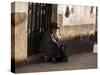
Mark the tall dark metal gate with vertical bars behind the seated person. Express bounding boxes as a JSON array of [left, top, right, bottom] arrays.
[[27, 3, 52, 56]]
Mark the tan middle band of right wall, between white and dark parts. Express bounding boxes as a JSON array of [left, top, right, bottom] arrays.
[[58, 24, 95, 39]]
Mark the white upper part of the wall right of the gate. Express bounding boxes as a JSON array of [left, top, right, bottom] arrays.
[[57, 4, 96, 25]]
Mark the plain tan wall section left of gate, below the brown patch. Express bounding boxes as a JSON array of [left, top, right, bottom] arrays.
[[15, 13, 27, 60]]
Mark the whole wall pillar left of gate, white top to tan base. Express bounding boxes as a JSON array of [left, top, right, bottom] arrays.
[[11, 2, 28, 61]]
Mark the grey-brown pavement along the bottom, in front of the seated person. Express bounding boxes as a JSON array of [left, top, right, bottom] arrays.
[[16, 52, 97, 73]]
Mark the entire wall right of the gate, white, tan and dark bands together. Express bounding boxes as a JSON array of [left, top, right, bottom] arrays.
[[57, 4, 97, 54]]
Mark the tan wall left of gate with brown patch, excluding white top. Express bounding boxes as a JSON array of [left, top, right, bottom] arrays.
[[12, 12, 27, 60]]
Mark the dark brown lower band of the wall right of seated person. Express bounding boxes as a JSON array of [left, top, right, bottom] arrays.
[[63, 34, 97, 55]]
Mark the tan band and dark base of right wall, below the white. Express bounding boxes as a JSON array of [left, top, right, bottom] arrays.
[[58, 24, 97, 55]]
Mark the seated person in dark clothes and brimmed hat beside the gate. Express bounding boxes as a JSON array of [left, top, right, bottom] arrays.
[[40, 23, 68, 63]]
